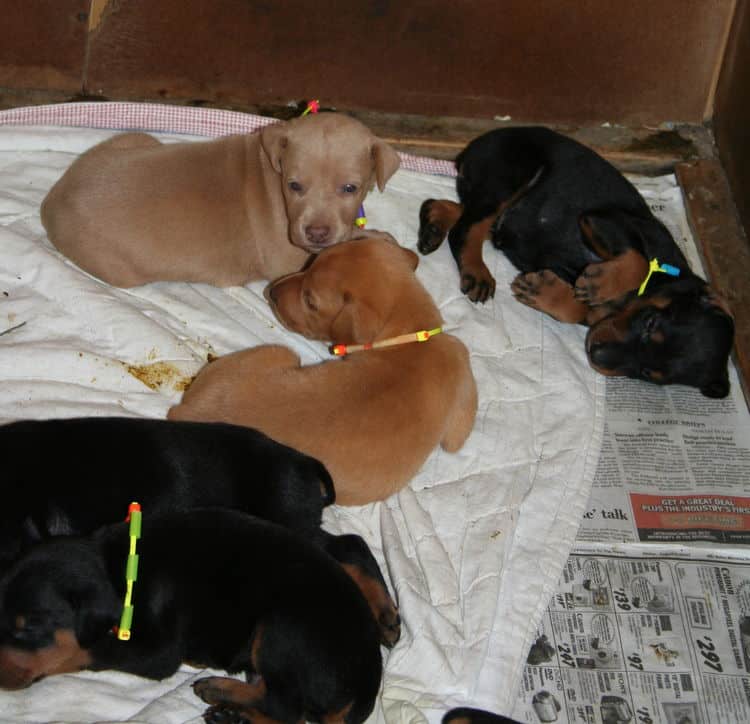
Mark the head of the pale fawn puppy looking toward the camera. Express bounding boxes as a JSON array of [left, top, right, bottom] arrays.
[[261, 113, 400, 254]]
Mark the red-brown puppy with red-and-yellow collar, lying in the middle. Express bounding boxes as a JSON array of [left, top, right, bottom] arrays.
[[169, 233, 477, 505]]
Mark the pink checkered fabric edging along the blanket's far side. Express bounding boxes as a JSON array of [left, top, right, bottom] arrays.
[[0, 102, 456, 176]]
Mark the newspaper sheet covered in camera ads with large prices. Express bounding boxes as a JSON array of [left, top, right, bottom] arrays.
[[514, 554, 750, 724]]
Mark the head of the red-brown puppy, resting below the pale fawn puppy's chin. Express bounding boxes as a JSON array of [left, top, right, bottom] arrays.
[[265, 232, 418, 344]]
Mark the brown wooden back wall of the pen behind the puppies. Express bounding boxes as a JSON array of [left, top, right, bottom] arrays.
[[0, 0, 735, 124]]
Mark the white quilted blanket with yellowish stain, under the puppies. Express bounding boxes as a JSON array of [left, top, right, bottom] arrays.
[[0, 121, 604, 724]]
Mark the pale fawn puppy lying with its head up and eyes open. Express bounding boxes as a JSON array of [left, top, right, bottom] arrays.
[[41, 113, 399, 287]]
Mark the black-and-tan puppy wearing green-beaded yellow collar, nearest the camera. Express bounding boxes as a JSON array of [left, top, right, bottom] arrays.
[[0, 508, 382, 724]]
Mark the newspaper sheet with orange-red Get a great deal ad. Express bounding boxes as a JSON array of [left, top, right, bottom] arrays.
[[578, 374, 750, 552]]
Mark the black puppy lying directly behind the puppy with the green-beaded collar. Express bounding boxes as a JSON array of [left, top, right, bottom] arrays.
[[0, 417, 400, 646]]
